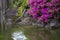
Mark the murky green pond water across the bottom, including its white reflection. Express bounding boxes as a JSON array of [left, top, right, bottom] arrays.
[[0, 25, 60, 40]]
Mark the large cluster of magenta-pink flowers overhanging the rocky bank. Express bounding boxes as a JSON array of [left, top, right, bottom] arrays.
[[27, 0, 60, 22]]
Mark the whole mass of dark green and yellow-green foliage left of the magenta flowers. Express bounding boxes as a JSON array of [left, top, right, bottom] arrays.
[[9, 0, 27, 17]]
